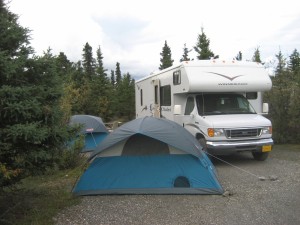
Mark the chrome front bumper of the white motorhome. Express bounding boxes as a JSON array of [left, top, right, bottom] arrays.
[[206, 138, 273, 155]]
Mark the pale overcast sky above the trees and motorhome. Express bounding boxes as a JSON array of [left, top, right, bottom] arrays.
[[8, 0, 300, 79]]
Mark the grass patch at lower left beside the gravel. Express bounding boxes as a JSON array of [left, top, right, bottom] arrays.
[[0, 163, 83, 225]]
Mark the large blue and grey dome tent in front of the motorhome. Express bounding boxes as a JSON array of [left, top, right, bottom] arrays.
[[73, 117, 223, 195]]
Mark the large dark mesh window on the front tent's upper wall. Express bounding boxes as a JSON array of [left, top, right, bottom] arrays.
[[122, 134, 170, 155]]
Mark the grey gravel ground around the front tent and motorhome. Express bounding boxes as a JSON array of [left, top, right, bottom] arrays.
[[54, 146, 300, 225]]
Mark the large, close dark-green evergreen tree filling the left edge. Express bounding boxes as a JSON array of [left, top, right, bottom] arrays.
[[0, 0, 67, 187]]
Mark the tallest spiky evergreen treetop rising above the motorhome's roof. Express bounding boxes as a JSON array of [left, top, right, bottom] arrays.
[[194, 27, 219, 60]]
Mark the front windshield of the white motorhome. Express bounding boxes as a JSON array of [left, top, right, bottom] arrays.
[[196, 93, 256, 116]]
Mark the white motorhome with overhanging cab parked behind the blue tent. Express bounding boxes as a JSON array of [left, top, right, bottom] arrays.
[[135, 60, 273, 160]]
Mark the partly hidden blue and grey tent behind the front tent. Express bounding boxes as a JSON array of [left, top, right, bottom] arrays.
[[70, 115, 108, 152]]
